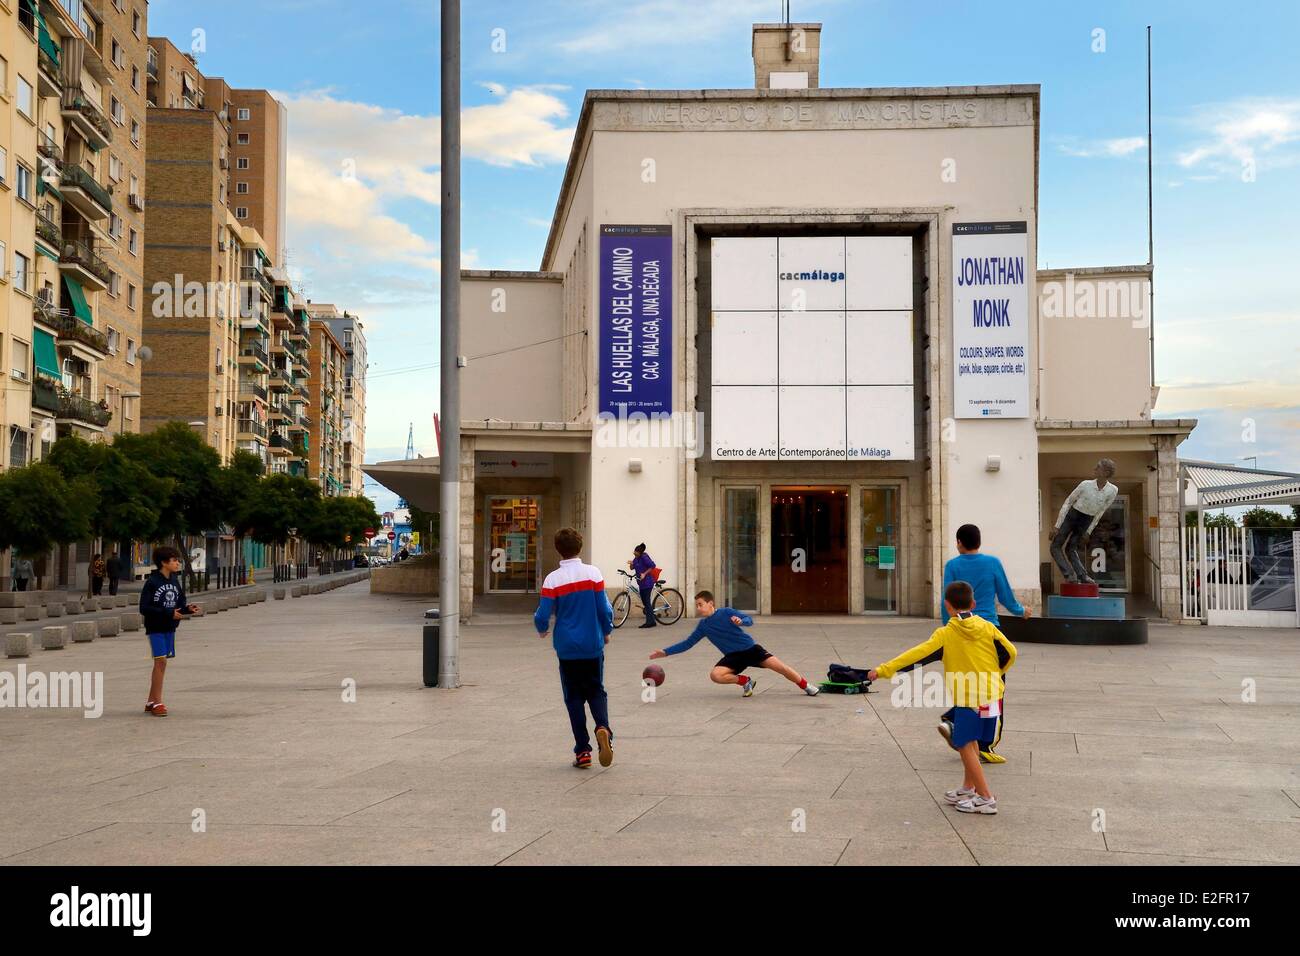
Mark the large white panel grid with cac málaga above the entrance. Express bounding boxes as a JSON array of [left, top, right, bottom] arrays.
[[711, 237, 915, 460]]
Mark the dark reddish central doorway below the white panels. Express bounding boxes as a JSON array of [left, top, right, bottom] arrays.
[[772, 485, 849, 614]]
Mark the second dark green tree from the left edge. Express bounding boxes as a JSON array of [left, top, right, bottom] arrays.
[[46, 436, 173, 541]]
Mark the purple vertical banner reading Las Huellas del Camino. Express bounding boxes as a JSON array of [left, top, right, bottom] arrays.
[[597, 226, 672, 415]]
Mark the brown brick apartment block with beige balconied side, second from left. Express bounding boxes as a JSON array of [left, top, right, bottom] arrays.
[[143, 36, 299, 472]]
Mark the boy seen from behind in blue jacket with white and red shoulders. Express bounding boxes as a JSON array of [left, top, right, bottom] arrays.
[[533, 528, 614, 770]]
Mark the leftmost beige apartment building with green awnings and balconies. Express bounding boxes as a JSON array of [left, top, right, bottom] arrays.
[[0, 0, 147, 464]]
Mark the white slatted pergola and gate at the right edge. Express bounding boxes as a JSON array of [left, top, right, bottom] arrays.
[[1178, 459, 1300, 627]]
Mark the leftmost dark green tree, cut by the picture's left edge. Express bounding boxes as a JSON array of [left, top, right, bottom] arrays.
[[0, 463, 96, 557]]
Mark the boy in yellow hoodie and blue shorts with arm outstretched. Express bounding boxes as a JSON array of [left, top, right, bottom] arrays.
[[867, 581, 1015, 813]]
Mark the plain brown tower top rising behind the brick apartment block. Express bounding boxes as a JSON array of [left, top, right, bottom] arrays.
[[230, 90, 289, 265]]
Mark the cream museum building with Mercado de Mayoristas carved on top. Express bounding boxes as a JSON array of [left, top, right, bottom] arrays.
[[371, 23, 1195, 619]]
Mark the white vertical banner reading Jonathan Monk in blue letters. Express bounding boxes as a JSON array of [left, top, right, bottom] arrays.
[[953, 222, 1032, 419]]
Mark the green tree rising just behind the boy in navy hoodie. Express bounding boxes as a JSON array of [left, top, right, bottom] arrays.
[[113, 421, 226, 568]]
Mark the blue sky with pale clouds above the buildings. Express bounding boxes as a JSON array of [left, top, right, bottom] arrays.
[[150, 0, 1300, 507]]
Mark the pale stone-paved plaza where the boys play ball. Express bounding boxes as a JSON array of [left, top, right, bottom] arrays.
[[0, 583, 1300, 865]]
